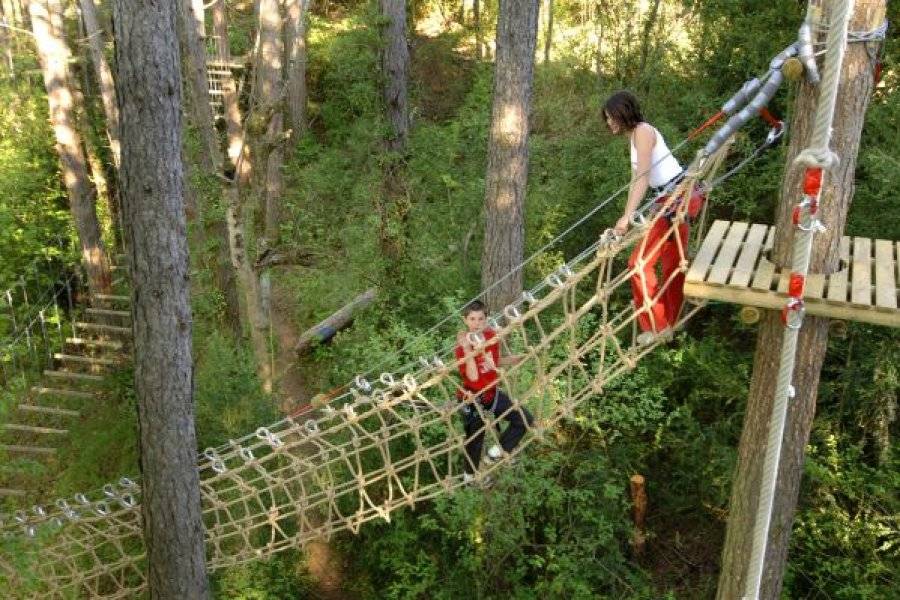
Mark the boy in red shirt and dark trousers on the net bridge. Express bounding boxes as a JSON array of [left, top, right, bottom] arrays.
[[455, 300, 532, 483]]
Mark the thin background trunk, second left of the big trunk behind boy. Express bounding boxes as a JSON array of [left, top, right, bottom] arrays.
[[284, 0, 312, 140]]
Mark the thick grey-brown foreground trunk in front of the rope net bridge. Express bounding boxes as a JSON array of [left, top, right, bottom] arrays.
[[115, 0, 209, 599]]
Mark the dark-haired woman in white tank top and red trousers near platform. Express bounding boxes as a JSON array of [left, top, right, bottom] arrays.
[[603, 91, 693, 345]]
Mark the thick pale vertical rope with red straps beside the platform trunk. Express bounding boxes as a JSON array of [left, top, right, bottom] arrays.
[[744, 0, 853, 600]]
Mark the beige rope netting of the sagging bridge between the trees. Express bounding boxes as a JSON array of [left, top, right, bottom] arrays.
[[0, 148, 725, 598]]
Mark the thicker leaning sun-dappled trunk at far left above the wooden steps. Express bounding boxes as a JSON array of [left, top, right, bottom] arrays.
[[28, 0, 110, 292]]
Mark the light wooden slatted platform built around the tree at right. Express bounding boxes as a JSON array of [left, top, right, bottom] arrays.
[[684, 221, 900, 327]]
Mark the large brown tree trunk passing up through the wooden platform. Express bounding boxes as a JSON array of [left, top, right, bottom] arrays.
[[717, 0, 885, 600]]
